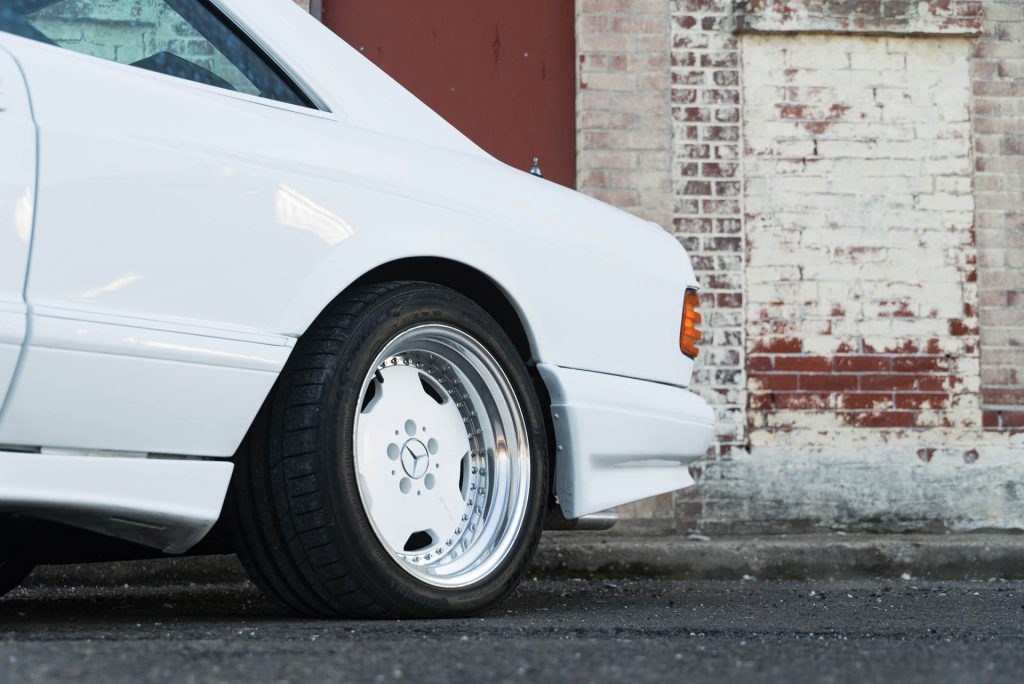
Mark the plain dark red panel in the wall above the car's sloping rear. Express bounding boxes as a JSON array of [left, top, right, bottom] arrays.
[[324, 0, 575, 187]]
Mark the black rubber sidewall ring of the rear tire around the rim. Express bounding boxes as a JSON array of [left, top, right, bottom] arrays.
[[301, 284, 548, 616]]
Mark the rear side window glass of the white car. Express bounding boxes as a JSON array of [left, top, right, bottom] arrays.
[[0, 0, 312, 106]]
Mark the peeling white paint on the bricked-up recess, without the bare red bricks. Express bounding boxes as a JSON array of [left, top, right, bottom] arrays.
[[743, 35, 979, 421]]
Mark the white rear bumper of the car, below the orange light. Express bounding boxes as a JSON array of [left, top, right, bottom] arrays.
[[538, 364, 715, 519]]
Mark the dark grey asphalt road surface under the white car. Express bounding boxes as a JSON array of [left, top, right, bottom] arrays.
[[0, 558, 1024, 684]]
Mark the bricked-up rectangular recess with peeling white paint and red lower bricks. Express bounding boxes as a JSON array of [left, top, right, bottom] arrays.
[[743, 35, 980, 432]]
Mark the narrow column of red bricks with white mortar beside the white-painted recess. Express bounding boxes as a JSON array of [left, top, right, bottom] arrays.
[[671, 0, 746, 528]]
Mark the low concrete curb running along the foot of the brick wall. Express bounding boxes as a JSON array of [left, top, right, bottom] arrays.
[[19, 532, 1024, 587]]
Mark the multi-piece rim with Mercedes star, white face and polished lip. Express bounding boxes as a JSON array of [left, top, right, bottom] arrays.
[[354, 325, 529, 588]]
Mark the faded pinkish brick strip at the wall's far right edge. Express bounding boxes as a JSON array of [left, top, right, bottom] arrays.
[[973, 0, 1024, 430]]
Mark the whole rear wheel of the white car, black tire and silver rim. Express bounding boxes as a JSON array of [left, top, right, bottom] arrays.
[[229, 283, 549, 617]]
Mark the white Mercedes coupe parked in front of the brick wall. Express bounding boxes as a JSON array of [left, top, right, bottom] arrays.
[[0, 0, 714, 616]]
